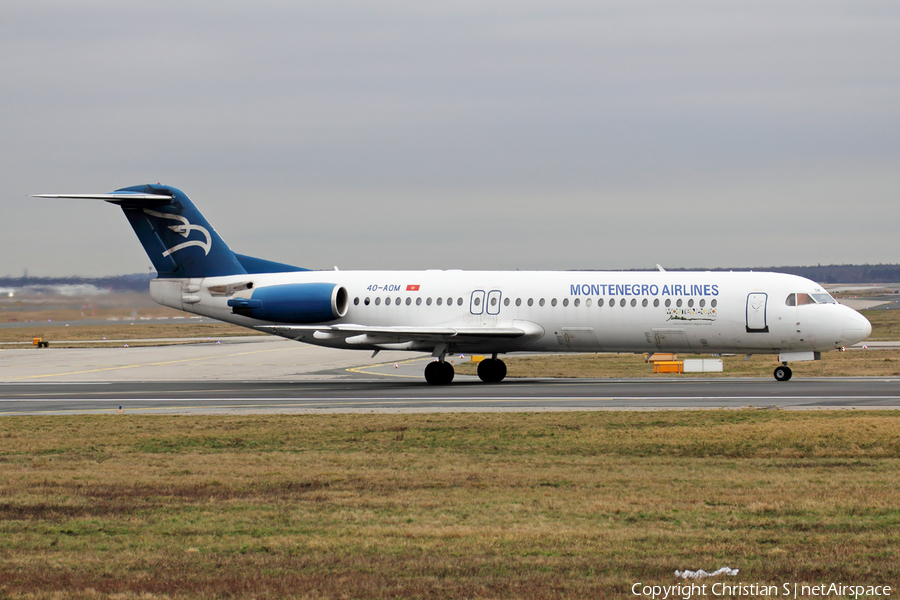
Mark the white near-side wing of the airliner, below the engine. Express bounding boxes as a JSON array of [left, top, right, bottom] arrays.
[[254, 321, 544, 345]]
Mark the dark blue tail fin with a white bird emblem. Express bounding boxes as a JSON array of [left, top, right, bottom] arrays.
[[108, 185, 247, 278]]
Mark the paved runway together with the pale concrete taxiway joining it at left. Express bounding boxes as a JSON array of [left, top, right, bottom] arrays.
[[0, 337, 900, 416]]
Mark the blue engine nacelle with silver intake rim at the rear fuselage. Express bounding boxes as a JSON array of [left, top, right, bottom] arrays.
[[228, 283, 350, 323]]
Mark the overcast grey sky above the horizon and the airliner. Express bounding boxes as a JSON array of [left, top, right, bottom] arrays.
[[0, 0, 900, 276]]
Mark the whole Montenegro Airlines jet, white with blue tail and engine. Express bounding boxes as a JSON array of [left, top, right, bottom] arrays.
[[39, 185, 872, 384]]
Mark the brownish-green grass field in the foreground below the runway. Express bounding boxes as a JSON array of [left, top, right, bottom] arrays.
[[0, 409, 900, 599]]
